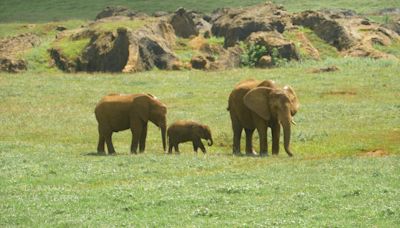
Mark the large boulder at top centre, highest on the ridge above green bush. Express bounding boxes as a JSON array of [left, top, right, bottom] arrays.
[[212, 2, 292, 47]]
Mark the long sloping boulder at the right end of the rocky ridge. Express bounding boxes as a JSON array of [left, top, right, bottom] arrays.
[[292, 10, 399, 58]]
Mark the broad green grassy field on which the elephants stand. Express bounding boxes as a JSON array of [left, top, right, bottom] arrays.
[[0, 58, 400, 227]]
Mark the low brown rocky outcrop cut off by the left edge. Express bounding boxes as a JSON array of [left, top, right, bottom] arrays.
[[0, 33, 40, 73]]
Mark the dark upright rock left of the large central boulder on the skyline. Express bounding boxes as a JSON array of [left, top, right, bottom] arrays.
[[169, 8, 199, 38]]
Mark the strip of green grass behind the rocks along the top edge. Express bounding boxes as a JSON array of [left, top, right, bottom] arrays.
[[0, 0, 399, 22]]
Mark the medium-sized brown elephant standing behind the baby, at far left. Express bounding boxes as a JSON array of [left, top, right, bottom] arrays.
[[94, 94, 167, 154]]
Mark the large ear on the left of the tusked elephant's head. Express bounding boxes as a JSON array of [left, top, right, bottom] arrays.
[[243, 87, 273, 120]]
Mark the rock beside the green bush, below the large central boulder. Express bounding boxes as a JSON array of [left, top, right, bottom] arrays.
[[246, 31, 300, 60]]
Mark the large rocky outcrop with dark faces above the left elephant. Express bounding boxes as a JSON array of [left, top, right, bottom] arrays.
[[49, 20, 177, 72]]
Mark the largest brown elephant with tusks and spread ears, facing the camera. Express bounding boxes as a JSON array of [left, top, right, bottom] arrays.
[[228, 79, 299, 156]]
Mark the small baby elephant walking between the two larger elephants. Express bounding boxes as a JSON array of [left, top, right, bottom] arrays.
[[167, 120, 213, 153]]
